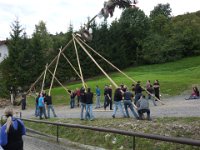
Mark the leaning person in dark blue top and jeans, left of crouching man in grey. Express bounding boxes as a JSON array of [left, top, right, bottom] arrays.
[[124, 89, 139, 119]]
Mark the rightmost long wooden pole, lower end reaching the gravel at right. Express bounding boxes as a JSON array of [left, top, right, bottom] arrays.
[[79, 38, 164, 105]]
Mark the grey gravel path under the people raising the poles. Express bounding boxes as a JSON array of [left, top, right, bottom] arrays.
[[0, 96, 200, 118]]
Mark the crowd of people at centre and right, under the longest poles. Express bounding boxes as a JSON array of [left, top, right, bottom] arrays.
[[64, 80, 160, 120]]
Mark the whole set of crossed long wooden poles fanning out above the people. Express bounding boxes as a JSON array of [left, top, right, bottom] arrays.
[[27, 34, 164, 107]]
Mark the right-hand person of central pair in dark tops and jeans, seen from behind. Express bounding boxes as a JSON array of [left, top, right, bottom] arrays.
[[85, 88, 94, 121]]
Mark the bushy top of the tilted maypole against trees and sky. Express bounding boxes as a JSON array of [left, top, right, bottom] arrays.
[[76, 0, 138, 42]]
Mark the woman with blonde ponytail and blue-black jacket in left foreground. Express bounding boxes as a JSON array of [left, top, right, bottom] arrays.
[[0, 107, 26, 150]]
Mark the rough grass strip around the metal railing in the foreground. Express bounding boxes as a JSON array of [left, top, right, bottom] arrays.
[[25, 117, 200, 150]]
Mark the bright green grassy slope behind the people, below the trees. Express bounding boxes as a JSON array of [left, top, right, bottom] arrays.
[[26, 56, 200, 105]]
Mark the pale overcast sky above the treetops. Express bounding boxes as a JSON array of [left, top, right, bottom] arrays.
[[0, 0, 200, 40]]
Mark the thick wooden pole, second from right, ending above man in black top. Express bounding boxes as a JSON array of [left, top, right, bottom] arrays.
[[73, 35, 118, 88]]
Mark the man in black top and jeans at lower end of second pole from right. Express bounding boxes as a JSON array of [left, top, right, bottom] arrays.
[[112, 87, 126, 118]]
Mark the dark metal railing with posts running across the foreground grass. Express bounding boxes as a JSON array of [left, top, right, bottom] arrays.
[[22, 119, 200, 150]]
